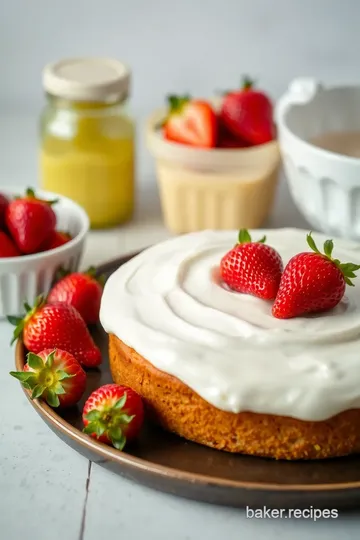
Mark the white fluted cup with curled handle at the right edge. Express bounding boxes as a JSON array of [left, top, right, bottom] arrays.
[[276, 78, 360, 241]]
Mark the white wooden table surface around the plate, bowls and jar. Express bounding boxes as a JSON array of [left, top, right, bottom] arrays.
[[0, 113, 360, 540]]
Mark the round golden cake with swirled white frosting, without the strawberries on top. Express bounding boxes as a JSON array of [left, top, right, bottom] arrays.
[[100, 229, 360, 459]]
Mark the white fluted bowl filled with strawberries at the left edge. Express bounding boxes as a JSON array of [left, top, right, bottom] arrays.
[[0, 189, 89, 317]]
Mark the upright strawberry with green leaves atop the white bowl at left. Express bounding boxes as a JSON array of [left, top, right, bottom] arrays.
[[5, 189, 56, 254]]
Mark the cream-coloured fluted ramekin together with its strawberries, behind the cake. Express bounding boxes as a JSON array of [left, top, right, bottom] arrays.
[[147, 80, 280, 234]]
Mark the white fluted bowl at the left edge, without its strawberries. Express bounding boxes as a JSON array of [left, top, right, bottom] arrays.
[[0, 189, 89, 317]]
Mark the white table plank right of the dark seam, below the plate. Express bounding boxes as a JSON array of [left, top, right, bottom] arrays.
[[84, 464, 360, 540]]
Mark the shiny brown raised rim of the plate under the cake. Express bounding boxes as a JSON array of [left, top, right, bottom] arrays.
[[15, 251, 360, 493]]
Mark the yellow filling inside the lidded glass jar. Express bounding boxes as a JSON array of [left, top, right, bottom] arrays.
[[40, 104, 135, 228]]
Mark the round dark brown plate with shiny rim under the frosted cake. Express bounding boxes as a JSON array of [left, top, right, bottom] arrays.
[[16, 257, 360, 509]]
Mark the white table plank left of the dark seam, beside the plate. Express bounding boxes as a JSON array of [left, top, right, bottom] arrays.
[[0, 322, 88, 540]]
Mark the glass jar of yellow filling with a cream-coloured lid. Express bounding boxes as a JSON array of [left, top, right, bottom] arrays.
[[40, 58, 135, 228]]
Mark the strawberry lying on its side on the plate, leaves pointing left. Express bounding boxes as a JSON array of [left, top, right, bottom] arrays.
[[8, 296, 101, 367]]
